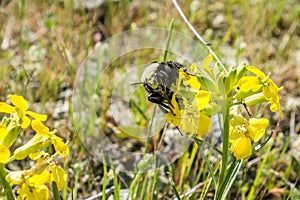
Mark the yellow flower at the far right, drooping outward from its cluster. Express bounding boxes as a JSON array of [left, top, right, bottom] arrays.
[[237, 66, 283, 117]]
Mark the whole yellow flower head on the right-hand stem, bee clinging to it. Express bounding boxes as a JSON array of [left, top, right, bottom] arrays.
[[165, 55, 283, 159]]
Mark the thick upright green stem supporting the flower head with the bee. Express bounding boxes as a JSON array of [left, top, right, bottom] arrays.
[[217, 97, 230, 197]]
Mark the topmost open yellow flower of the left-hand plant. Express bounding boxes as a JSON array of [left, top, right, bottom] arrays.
[[0, 95, 47, 128]]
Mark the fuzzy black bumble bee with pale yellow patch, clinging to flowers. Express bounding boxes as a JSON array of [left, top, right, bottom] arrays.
[[142, 61, 187, 114]]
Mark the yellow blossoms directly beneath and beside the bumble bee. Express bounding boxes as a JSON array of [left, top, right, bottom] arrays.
[[165, 66, 212, 137]]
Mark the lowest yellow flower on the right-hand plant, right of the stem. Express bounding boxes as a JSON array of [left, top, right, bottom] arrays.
[[229, 116, 269, 159]]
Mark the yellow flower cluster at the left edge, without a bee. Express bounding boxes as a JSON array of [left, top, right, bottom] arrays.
[[0, 95, 69, 199]]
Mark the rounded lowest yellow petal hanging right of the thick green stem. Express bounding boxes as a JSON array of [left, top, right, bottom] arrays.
[[229, 137, 252, 159]]
